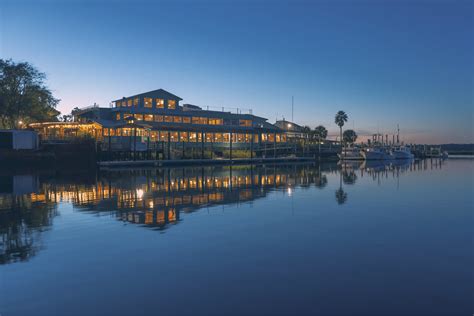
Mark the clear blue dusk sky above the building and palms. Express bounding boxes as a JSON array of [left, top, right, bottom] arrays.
[[0, 0, 474, 144]]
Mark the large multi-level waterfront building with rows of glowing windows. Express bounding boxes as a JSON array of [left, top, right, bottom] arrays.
[[30, 89, 287, 156]]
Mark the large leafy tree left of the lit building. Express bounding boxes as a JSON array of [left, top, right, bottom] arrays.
[[0, 59, 59, 128]]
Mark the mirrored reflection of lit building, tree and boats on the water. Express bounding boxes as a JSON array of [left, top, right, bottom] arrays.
[[0, 161, 442, 264]]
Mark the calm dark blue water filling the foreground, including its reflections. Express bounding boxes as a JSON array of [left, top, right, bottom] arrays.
[[0, 160, 474, 316]]
